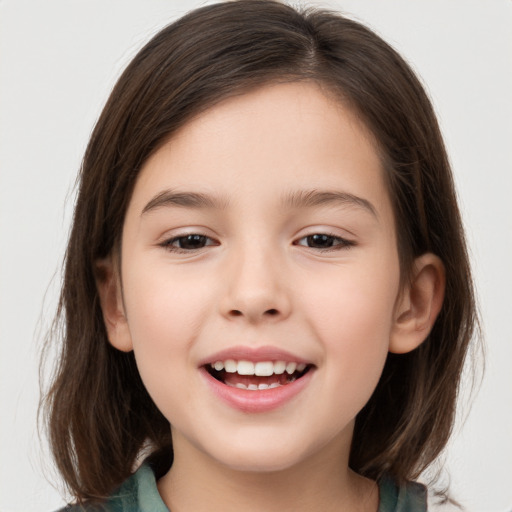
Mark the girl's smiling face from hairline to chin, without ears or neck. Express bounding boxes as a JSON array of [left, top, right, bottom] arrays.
[[112, 83, 399, 471]]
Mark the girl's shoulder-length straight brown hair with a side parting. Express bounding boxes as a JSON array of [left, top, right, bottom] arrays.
[[44, 0, 476, 501]]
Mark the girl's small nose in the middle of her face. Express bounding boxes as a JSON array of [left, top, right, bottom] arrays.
[[220, 246, 291, 324]]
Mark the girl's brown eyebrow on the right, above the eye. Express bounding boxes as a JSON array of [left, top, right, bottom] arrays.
[[283, 190, 378, 218]]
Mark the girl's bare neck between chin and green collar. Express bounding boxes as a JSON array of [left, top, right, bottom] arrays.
[[158, 428, 378, 512]]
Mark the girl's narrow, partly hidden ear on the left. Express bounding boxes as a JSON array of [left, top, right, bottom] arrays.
[[95, 257, 133, 352]]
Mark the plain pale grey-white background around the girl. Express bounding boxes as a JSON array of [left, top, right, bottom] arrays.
[[0, 0, 512, 512]]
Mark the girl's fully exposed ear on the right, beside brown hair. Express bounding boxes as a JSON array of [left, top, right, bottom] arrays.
[[389, 253, 445, 354]]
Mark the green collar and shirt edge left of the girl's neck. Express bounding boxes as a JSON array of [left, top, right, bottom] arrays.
[[57, 464, 169, 512]]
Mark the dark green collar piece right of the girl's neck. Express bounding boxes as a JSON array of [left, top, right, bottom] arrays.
[[378, 475, 427, 512]]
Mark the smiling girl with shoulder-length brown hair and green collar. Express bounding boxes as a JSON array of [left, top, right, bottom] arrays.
[[42, 0, 475, 512]]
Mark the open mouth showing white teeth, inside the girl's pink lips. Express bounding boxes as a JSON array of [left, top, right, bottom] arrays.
[[205, 359, 313, 391]]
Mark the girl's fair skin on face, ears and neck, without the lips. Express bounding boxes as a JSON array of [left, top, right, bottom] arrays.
[[98, 82, 444, 512]]
